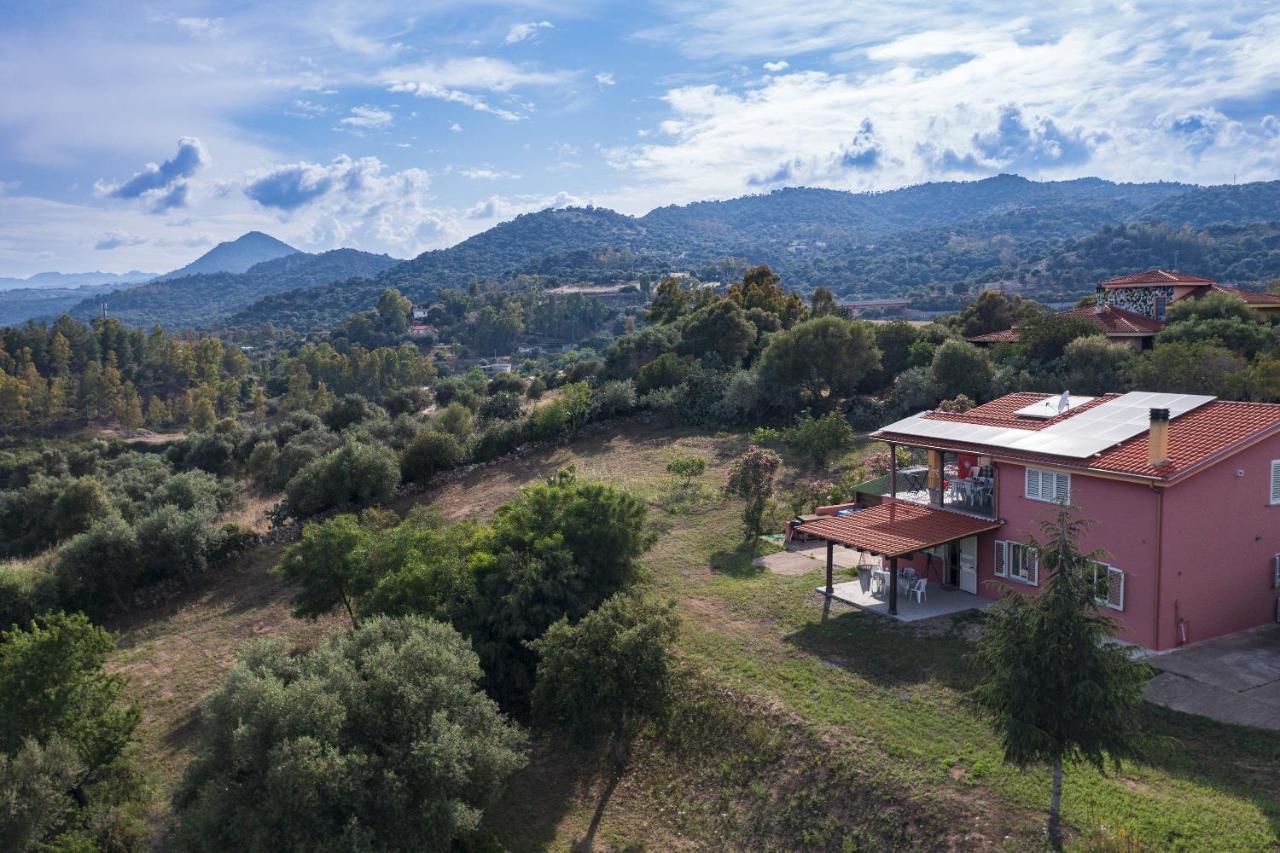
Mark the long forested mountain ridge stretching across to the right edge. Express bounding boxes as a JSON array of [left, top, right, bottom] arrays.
[[230, 175, 1280, 328]]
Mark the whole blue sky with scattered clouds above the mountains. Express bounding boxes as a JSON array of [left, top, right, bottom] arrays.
[[0, 0, 1280, 275]]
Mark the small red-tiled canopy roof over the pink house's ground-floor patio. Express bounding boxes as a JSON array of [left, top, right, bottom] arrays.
[[796, 501, 1001, 557]]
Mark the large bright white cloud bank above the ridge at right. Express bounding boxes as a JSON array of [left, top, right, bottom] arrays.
[[607, 9, 1280, 204]]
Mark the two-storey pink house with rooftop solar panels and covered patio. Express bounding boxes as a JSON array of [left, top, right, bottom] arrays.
[[792, 392, 1280, 649]]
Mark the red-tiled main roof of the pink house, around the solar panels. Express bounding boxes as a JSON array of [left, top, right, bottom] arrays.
[[876, 392, 1280, 480]]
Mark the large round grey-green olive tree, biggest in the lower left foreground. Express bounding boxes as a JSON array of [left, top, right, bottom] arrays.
[[177, 616, 526, 853]]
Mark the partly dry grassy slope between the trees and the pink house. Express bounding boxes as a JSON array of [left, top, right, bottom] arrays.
[[107, 424, 1280, 850]]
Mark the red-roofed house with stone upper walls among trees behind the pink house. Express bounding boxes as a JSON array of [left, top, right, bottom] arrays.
[[966, 269, 1280, 350]]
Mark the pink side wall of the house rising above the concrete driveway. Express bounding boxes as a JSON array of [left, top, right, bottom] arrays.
[[1160, 437, 1280, 648]]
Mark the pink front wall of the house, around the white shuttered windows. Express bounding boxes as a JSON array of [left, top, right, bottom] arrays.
[[978, 461, 1157, 646]]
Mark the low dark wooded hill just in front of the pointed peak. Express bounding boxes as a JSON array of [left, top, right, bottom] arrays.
[[68, 248, 399, 329]]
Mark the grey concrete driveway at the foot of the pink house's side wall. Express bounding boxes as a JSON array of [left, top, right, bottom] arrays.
[[1147, 625, 1280, 731]]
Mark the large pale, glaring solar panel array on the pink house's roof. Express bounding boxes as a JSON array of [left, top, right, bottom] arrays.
[[884, 391, 1215, 459]]
